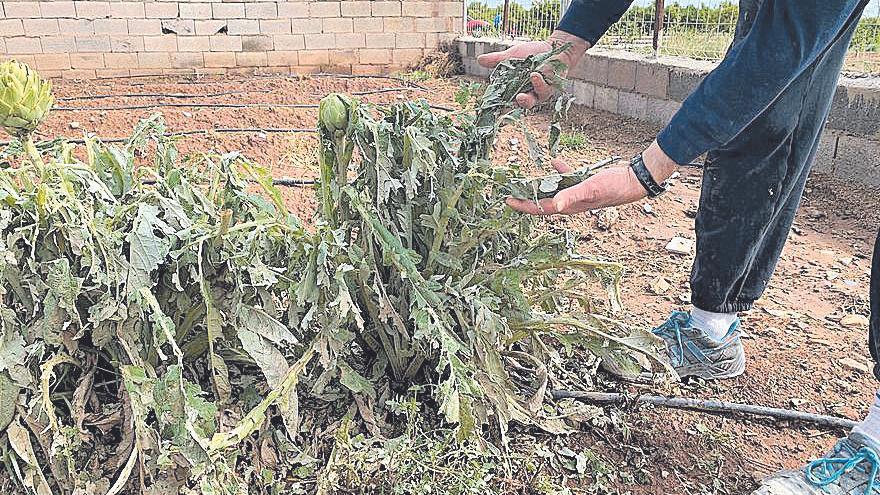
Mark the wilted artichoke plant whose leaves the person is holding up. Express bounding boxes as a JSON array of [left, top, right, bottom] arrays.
[[301, 45, 660, 439]]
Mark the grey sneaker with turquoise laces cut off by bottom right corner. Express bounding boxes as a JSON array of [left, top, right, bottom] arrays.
[[752, 433, 880, 495]]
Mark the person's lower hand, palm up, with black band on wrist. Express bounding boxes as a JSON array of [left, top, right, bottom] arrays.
[[507, 141, 677, 215]]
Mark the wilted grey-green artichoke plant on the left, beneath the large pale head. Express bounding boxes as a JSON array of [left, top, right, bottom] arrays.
[[0, 116, 308, 493]]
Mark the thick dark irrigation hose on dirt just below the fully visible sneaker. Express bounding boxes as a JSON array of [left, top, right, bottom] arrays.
[[551, 390, 857, 429]]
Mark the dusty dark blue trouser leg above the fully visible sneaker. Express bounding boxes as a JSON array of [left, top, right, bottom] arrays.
[[691, 0, 861, 313]]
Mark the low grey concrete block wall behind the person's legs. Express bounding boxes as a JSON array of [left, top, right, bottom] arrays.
[[458, 37, 880, 186]]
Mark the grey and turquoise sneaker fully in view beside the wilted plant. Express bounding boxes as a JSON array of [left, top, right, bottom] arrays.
[[653, 311, 746, 380]]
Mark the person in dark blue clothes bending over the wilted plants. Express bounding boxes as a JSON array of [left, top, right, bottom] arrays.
[[478, 0, 880, 495]]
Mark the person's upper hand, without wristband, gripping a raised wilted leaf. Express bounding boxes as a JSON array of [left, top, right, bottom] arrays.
[[477, 31, 590, 109]]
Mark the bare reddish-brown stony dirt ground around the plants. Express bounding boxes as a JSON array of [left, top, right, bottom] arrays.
[[34, 71, 880, 494]]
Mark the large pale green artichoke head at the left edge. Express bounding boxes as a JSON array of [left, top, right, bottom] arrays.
[[0, 60, 54, 138]]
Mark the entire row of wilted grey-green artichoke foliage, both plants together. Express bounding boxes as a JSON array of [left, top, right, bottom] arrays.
[[0, 47, 662, 495]]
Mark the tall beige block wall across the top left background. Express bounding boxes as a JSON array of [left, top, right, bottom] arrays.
[[0, 0, 463, 78]]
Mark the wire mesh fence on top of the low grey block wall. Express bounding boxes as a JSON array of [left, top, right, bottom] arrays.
[[465, 0, 880, 74]]
